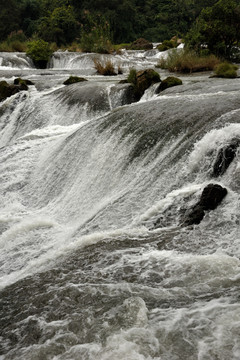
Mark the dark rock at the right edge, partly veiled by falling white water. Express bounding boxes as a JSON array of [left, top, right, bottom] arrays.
[[212, 139, 240, 177]]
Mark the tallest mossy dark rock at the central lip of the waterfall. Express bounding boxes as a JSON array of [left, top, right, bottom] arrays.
[[127, 69, 161, 101]]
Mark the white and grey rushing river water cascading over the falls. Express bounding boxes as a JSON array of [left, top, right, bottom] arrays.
[[0, 51, 240, 360]]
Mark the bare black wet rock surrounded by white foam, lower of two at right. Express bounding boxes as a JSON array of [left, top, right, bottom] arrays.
[[182, 184, 227, 226]]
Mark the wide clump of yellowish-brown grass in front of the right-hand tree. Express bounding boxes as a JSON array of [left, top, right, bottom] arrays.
[[157, 50, 219, 73]]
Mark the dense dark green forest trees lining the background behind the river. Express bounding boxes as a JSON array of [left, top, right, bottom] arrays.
[[0, 0, 240, 57]]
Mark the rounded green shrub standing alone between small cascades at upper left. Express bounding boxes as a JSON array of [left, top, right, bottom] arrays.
[[27, 39, 53, 69]]
